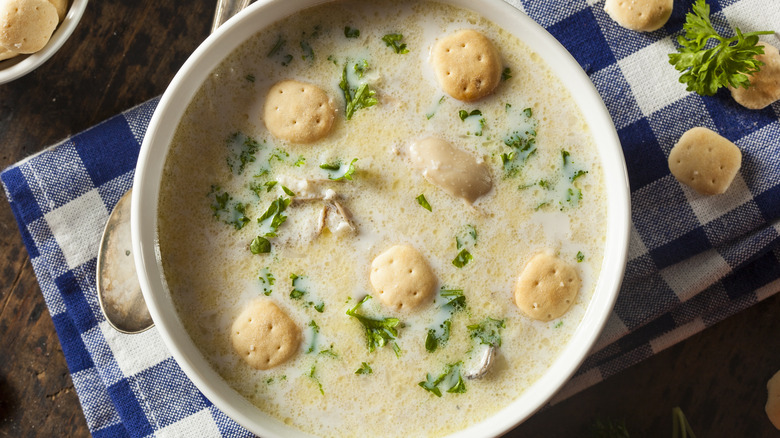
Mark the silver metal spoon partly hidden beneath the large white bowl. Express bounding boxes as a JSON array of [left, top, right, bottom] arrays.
[[96, 0, 251, 334]]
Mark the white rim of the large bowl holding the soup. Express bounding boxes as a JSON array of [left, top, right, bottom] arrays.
[[131, 0, 630, 438]]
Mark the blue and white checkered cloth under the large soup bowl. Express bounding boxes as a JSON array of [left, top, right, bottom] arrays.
[[1, 0, 780, 437]]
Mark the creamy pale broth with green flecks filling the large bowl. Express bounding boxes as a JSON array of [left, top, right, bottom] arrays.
[[158, 1, 606, 436]]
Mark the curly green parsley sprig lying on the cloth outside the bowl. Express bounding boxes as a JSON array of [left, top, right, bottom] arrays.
[[669, 0, 774, 96]]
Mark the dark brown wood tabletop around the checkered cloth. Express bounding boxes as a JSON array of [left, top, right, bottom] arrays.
[[0, 0, 780, 438]]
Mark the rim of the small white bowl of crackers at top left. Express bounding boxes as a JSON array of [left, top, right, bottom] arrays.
[[0, 0, 87, 84]]
